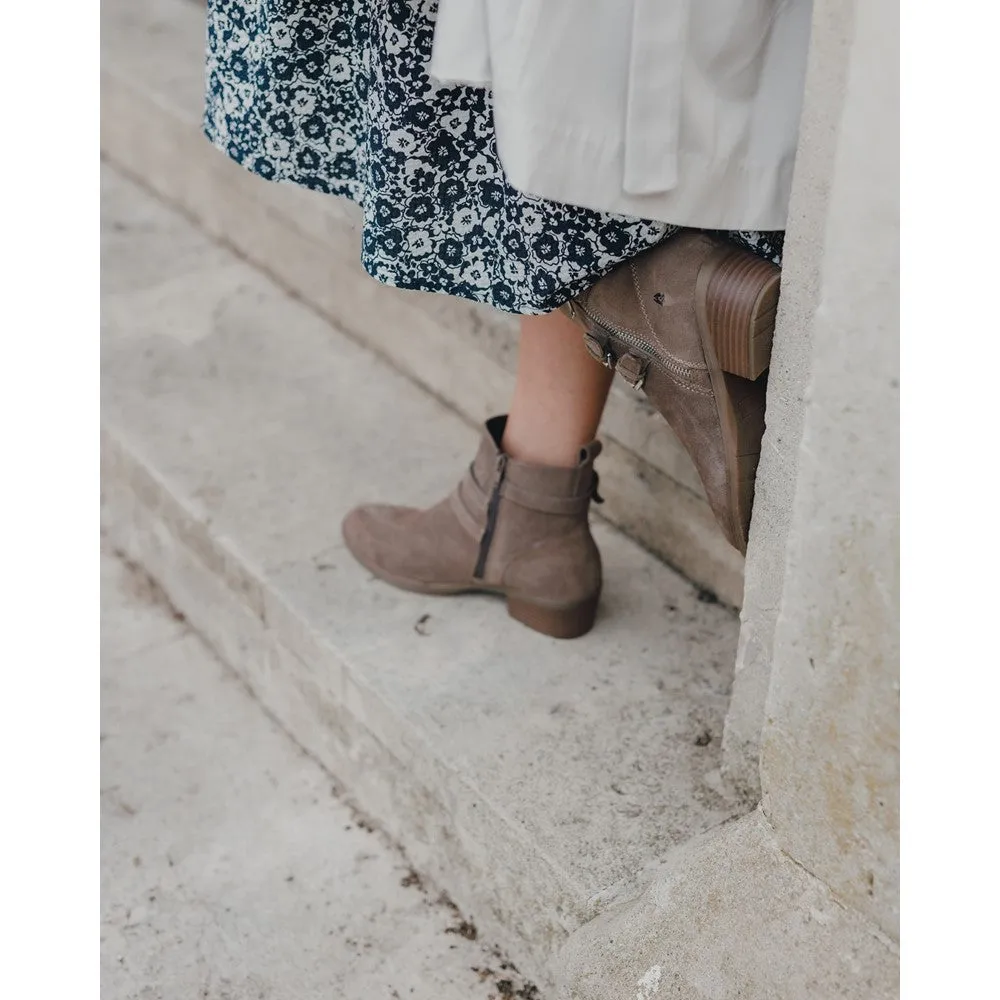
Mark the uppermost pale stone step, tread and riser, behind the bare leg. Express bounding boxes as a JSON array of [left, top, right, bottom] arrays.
[[101, 0, 743, 606]]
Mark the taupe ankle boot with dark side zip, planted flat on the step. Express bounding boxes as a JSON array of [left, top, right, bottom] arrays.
[[343, 416, 601, 639]]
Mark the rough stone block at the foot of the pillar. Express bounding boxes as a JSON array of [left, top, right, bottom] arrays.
[[558, 812, 899, 1000]]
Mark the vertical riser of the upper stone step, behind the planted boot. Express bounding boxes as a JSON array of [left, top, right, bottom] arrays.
[[101, 67, 743, 607]]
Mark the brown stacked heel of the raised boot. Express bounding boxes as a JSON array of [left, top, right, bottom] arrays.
[[696, 248, 781, 381]]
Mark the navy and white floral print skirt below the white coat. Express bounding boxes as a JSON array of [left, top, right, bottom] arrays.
[[204, 0, 783, 313]]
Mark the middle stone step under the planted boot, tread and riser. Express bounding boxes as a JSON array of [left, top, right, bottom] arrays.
[[102, 165, 740, 985]]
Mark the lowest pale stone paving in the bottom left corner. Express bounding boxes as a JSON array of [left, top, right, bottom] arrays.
[[101, 552, 542, 1000]]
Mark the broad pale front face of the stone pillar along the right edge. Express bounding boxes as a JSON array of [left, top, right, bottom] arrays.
[[761, 2, 899, 937]]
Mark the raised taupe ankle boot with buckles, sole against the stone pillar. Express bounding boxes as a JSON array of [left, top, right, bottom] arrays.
[[563, 231, 781, 552]]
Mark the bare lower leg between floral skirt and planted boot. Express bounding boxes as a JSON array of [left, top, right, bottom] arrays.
[[503, 311, 614, 467]]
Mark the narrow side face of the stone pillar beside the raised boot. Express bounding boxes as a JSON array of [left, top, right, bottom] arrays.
[[723, 0, 868, 802]]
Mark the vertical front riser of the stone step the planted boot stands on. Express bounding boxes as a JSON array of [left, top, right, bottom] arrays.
[[101, 424, 616, 987]]
